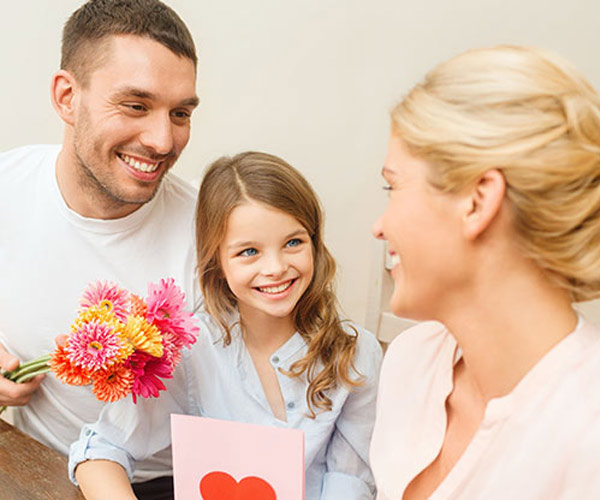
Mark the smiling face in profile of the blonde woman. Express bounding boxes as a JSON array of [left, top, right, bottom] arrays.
[[373, 134, 465, 320]]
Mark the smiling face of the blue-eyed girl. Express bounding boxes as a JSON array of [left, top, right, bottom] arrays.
[[219, 201, 314, 318]]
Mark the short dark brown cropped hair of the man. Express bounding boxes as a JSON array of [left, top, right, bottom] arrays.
[[60, 0, 198, 85]]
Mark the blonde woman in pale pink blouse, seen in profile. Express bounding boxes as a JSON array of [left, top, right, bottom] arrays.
[[371, 46, 600, 500]]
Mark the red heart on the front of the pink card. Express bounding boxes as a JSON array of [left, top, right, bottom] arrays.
[[200, 471, 277, 500]]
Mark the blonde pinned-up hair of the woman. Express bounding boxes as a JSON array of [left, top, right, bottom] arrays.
[[391, 46, 600, 301]]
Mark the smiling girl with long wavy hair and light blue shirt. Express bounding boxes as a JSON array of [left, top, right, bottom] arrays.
[[70, 152, 381, 500]]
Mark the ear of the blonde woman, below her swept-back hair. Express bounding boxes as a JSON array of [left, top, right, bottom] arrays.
[[463, 169, 506, 240]]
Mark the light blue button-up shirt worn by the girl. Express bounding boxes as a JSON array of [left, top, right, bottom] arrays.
[[69, 314, 381, 500]]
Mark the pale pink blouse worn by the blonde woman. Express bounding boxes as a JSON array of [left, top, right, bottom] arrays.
[[370, 320, 600, 500]]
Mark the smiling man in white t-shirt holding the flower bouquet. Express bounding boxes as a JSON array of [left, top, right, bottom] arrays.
[[0, 0, 199, 498]]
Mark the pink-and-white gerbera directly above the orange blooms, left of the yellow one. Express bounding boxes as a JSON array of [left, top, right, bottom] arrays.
[[66, 320, 124, 371]]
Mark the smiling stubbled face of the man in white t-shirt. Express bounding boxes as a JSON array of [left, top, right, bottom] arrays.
[[73, 35, 198, 218]]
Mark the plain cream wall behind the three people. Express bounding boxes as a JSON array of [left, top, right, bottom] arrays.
[[0, 0, 600, 323]]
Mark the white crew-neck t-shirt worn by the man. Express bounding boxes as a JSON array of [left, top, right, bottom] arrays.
[[0, 145, 200, 480]]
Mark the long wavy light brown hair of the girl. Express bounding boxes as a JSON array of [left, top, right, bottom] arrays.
[[196, 152, 362, 418]]
